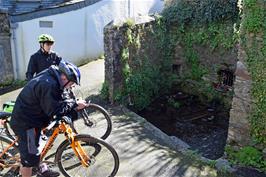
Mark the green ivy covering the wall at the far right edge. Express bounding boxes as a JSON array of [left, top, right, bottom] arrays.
[[240, 0, 266, 146]]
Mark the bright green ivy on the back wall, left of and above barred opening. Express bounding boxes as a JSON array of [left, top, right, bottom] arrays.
[[171, 21, 238, 103]]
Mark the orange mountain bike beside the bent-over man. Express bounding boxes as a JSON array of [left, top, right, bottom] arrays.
[[0, 112, 119, 177]]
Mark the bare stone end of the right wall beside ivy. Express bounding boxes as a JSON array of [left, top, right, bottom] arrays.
[[228, 57, 252, 146]]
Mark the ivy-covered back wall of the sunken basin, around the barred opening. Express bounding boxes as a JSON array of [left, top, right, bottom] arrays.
[[162, 0, 238, 108]]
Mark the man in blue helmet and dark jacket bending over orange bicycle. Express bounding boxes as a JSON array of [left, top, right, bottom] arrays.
[[10, 60, 86, 177]]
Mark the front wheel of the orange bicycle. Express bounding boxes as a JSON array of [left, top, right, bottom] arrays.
[[55, 135, 119, 177]]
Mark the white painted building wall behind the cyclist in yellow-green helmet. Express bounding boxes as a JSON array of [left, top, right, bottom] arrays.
[[12, 0, 163, 79]]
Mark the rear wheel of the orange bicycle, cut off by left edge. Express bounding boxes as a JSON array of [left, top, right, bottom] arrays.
[[0, 136, 20, 176]]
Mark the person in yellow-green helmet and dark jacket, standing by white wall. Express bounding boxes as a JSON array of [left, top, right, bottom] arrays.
[[26, 34, 61, 81]]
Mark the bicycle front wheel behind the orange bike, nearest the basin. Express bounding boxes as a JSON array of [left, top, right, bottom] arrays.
[[74, 103, 112, 139]]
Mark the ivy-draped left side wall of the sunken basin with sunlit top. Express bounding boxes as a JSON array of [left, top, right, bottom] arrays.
[[103, 17, 171, 110]]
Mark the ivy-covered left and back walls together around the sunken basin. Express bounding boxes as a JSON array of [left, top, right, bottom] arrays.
[[103, 0, 238, 110]]
